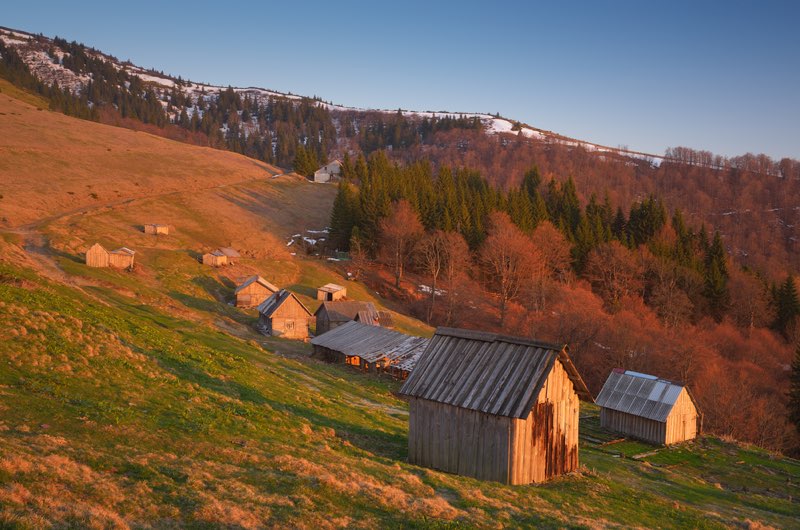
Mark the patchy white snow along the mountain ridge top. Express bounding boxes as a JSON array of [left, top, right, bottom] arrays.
[[0, 27, 663, 164]]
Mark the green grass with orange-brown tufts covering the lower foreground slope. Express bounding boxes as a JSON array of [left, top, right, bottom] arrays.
[[0, 253, 800, 528]]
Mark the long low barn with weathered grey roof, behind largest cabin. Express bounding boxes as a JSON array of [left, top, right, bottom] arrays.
[[311, 321, 429, 378]]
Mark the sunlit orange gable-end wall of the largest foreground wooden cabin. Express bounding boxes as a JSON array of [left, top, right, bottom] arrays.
[[509, 361, 580, 484]]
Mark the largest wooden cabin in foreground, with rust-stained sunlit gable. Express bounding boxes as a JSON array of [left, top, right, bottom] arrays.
[[400, 328, 592, 484]]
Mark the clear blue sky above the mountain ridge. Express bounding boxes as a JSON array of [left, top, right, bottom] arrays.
[[0, 0, 800, 158]]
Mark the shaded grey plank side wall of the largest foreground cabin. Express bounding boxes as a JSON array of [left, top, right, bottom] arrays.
[[408, 398, 511, 482]]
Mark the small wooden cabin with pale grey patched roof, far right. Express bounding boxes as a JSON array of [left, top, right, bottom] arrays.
[[597, 369, 702, 445]]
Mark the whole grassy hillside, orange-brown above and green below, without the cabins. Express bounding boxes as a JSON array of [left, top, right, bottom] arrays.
[[0, 88, 800, 528]]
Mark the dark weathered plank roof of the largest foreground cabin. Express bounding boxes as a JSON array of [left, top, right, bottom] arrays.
[[400, 328, 592, 418]]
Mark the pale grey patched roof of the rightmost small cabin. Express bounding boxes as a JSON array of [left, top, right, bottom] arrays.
[[597, 369, 694, 422]]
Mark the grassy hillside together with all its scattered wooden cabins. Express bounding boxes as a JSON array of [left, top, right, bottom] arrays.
[[0, 24, 800, 528]]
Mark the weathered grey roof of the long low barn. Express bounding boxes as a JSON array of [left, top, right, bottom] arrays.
[[311, 322, 429, 363]]
